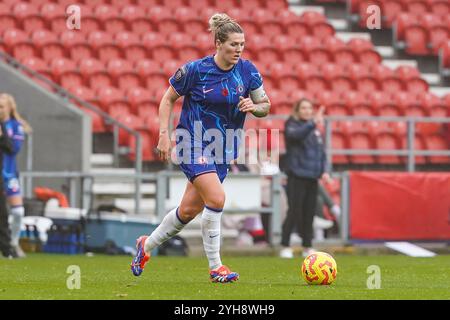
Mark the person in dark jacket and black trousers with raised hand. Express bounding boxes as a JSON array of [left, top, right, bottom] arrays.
[[280, 99, 330, 258]]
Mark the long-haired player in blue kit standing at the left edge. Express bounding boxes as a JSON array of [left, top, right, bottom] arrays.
[[0, 93, 31, 257]]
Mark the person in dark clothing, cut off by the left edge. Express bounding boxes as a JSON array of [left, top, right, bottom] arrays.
[[0, 122, 13, 257]]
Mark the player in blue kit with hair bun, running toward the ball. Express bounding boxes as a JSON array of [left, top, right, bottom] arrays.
[[131, 13, 270, 283]]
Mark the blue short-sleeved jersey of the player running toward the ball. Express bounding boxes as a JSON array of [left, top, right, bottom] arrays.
[[169, 56, 263, 160]]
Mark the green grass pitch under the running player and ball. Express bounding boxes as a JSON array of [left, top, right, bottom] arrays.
[[0, 254, 450, 300]]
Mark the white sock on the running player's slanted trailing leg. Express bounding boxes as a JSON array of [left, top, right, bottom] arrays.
[[144, 208, 187, 253]]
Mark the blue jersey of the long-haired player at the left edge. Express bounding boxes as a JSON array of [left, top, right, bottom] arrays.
[[3, 118, 25, 180]]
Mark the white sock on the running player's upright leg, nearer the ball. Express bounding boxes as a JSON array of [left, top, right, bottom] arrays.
[[202, 206, 222, 269]]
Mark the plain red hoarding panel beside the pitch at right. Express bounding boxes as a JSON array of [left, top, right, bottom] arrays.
[[350, 172, 450, 240]]
